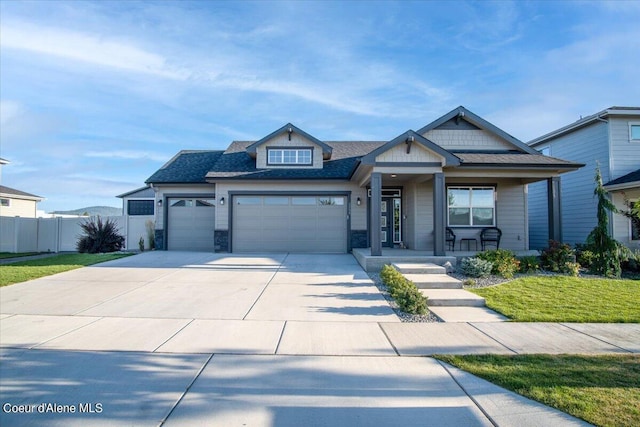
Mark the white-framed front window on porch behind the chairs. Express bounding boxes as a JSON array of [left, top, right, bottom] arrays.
[[447, 187, 495, 227]]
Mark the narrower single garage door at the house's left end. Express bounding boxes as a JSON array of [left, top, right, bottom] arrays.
[[167, 197, 216, 251]]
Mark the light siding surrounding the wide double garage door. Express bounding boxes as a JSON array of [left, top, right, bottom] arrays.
[[216, 181, 367, 230]]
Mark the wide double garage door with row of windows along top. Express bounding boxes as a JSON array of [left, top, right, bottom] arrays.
[[232, 196, 347, 253]]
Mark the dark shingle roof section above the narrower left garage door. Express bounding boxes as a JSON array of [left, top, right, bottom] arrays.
[[145, 150, 223, 184]]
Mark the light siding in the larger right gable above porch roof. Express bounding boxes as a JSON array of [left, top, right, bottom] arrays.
[[423, 129, 514, 150]]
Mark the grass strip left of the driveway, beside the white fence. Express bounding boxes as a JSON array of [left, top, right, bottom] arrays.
[[0, 252, 131, 286]]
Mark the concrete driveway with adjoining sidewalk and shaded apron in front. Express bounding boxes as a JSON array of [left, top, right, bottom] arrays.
[[0, 252, 640, 426]]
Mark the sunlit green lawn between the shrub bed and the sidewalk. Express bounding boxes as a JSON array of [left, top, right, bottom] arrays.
[[468, 276, 640, 323]]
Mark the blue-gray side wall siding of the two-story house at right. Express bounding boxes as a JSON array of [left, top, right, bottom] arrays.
[[529, 122, 611, 246]]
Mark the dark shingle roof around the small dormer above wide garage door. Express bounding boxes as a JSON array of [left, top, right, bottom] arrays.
[[207, 141, 384, 180]]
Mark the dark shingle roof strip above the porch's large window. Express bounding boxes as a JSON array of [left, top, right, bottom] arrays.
[[453, 152, 584, 168]]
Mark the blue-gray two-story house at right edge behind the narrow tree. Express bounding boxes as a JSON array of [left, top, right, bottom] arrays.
[[529, 107, 640, 249]]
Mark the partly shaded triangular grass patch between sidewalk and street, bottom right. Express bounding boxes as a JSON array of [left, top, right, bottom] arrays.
[[437, 355, 640, 426]]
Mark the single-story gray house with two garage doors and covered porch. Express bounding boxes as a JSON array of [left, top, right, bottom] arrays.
[[147, 107, 582, 255]]
